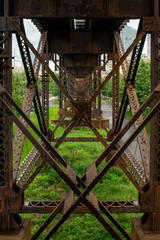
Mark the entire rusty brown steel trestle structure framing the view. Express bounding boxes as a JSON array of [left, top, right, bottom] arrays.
[[0, 0, 160, 240]]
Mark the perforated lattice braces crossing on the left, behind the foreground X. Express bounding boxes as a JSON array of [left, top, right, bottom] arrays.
[[13, 32, 49, 178]]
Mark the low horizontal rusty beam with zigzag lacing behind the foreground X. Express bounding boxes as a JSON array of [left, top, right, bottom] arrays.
[[22, 201, 141, 213]]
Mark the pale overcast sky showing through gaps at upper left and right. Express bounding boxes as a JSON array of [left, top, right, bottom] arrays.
[[13, 20, 147, 67]]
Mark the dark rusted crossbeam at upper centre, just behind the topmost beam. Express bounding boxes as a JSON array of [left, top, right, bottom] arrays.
[[48, 29, 116, 54]]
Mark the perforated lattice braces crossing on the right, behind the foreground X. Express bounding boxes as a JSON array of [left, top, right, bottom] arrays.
[[115, 27, 150, 179]]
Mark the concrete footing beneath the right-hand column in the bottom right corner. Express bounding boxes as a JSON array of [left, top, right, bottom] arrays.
[[132, 218, 160, 240]]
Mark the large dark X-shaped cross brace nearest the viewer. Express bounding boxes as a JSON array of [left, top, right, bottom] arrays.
[[0, 86, 160, 239]]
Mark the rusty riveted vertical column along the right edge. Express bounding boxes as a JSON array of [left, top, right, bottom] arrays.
[[141, 0, 160, 233]]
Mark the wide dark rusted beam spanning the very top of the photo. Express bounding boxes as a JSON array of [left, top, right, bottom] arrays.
[[10, 0, 154, 18]]
